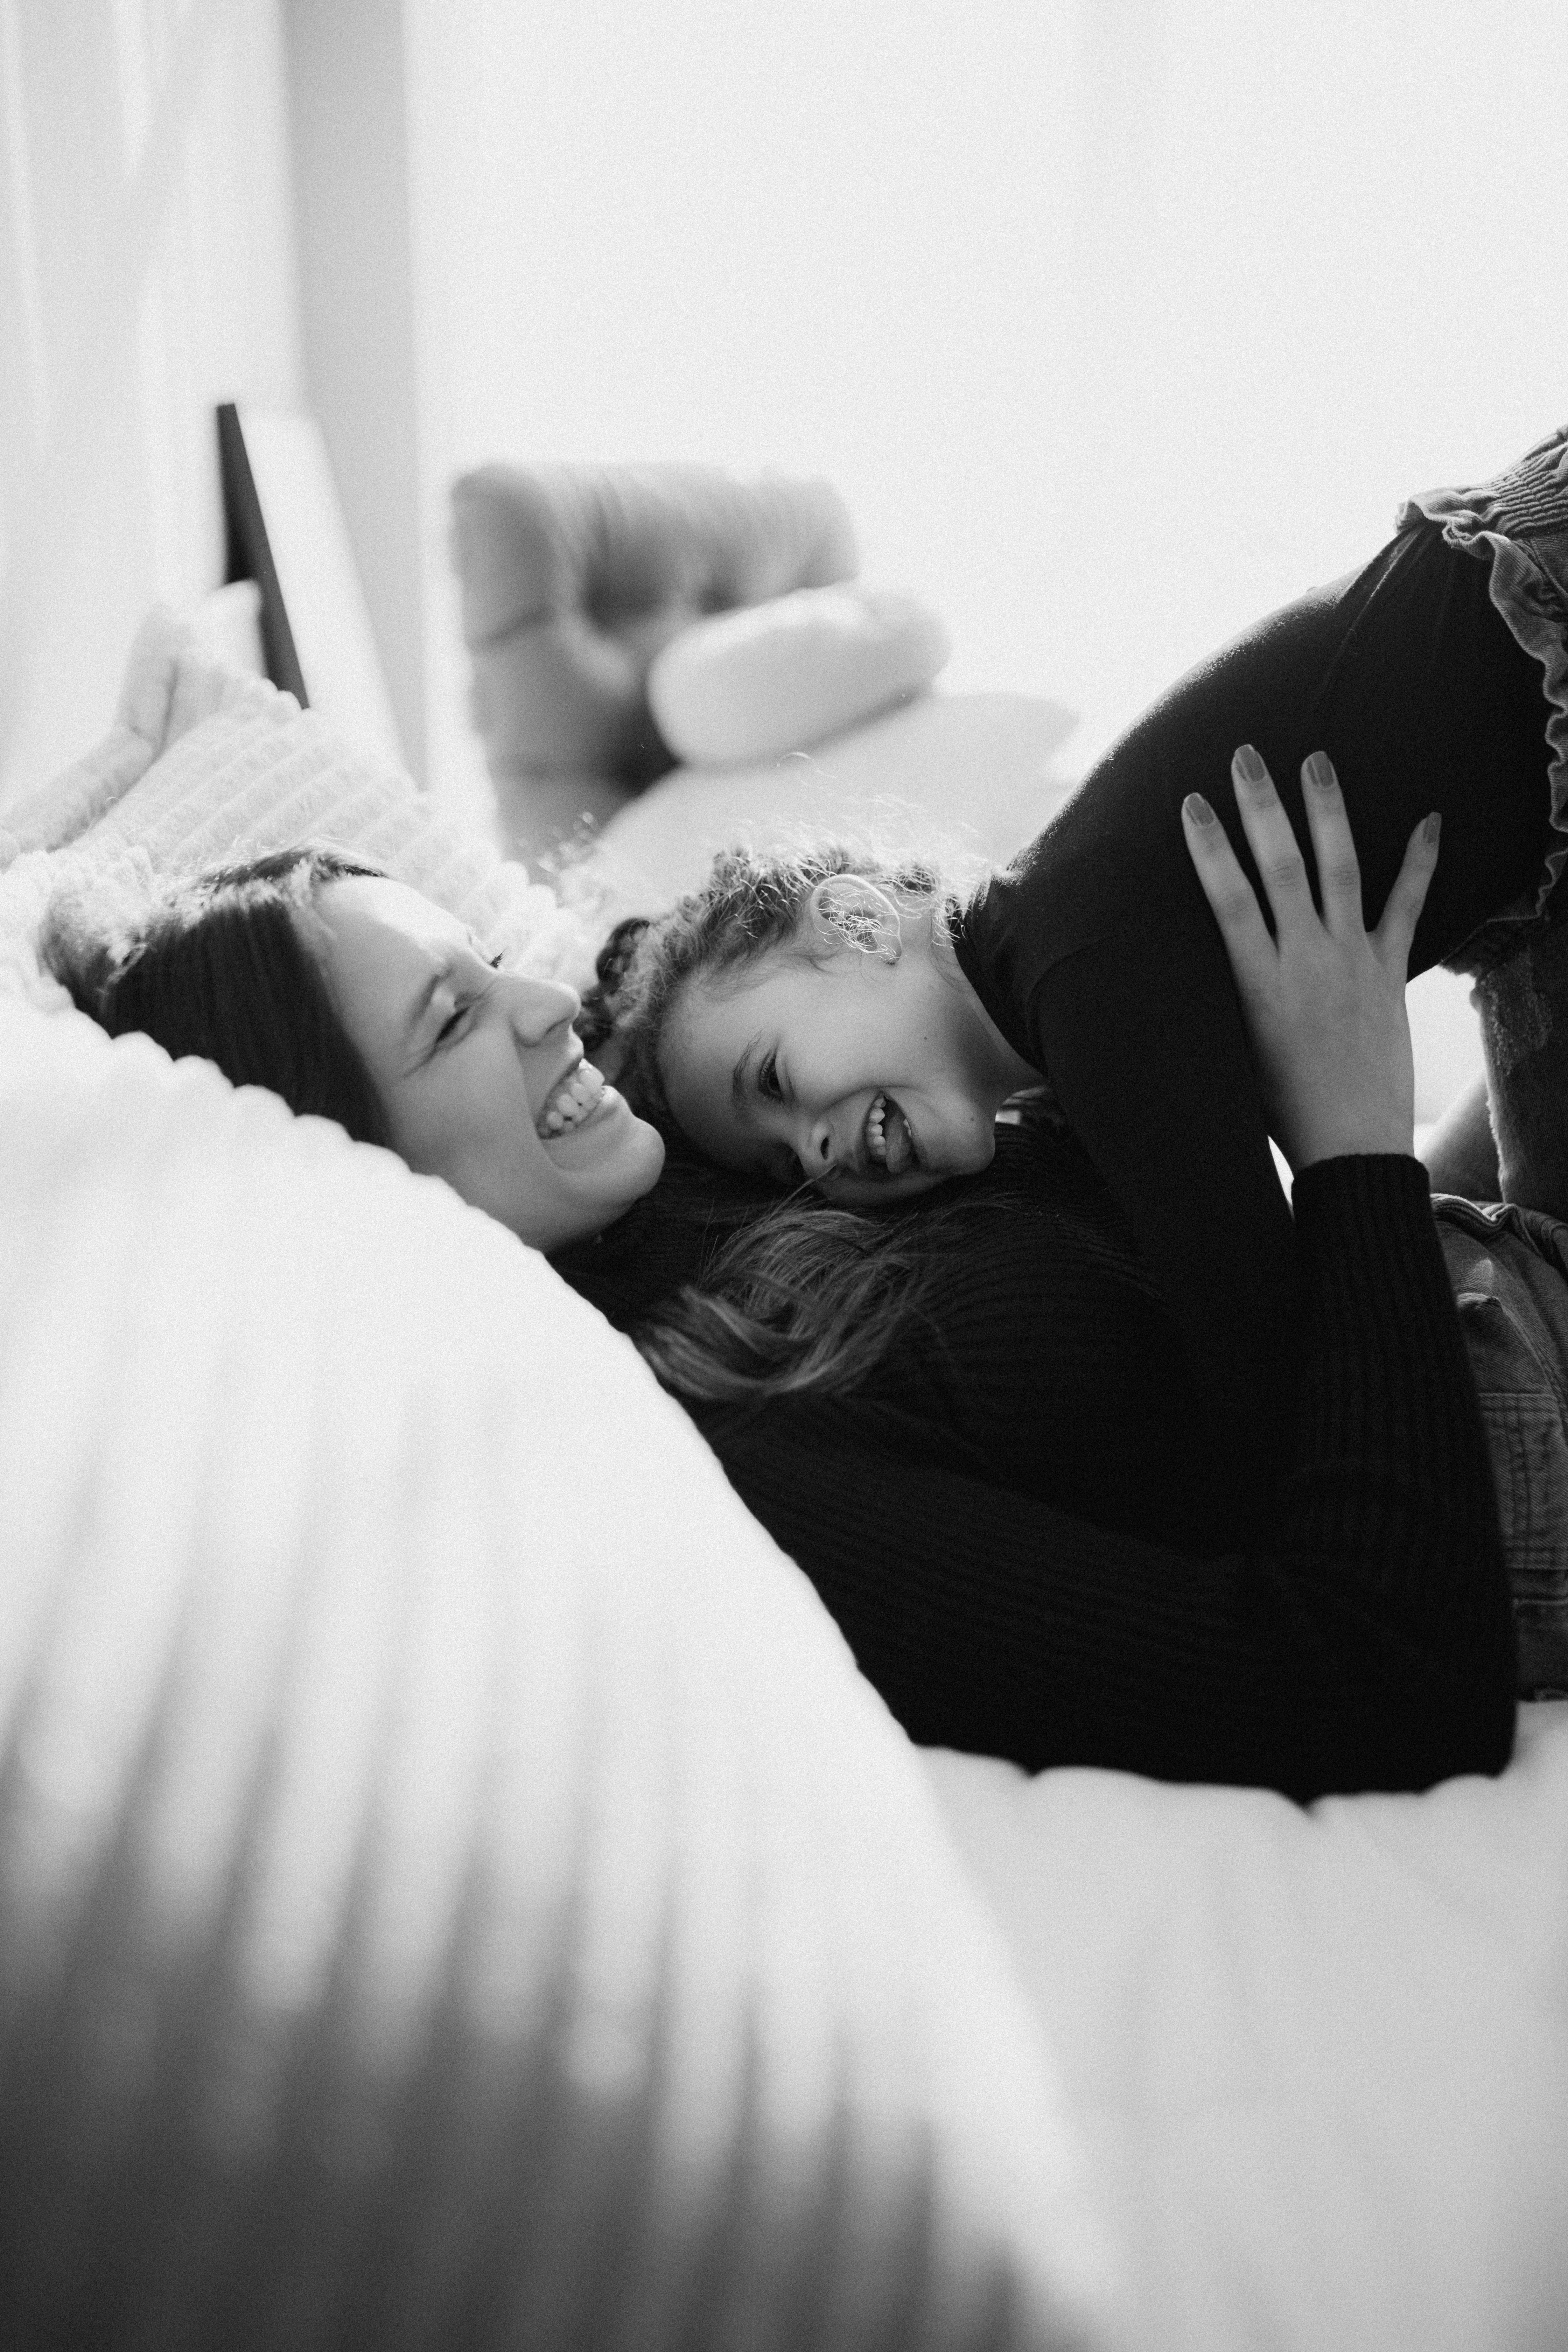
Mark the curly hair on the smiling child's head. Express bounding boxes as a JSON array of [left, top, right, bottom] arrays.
[[578, 842, 952, 1136]]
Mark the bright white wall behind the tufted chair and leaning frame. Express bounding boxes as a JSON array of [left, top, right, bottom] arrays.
[[0, 0, 1568, 847]]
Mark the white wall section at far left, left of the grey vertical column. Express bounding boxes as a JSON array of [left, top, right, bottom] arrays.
[[0, 0, 301, 797]]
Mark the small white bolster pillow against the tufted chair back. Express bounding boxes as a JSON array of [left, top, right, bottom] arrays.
[[649, 583, 952, 767]]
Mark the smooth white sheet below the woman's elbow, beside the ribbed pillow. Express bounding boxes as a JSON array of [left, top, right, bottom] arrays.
[[926, 1703, 1568, 2352]]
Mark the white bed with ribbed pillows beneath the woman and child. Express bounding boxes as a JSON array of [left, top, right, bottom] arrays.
[[0, 449, 1568, 2352]]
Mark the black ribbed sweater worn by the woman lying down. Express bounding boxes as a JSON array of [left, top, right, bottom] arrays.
[[562, 1129, 1514, 1799]]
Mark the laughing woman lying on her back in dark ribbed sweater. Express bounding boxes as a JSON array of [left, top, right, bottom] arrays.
[[54, 752, 1514, 1799]]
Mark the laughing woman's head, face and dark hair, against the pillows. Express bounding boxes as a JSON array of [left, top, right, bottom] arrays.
[[42, 849, 665, 1249]]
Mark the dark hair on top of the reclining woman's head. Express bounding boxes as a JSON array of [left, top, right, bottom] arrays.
[[40, 844, 390, 1143]]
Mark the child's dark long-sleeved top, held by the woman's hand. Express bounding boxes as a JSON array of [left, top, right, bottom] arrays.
[[957, 525, 1552, 1531]]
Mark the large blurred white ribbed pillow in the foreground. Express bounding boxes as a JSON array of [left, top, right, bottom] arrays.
[[0, 993, 1105, 2352]]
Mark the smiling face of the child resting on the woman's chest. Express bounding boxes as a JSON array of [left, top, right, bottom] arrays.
[[658, 920, 1027, 1206]]
